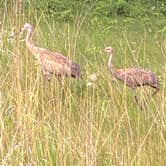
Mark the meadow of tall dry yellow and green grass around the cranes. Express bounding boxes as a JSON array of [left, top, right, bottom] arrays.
[[0, 1, 166, 166]]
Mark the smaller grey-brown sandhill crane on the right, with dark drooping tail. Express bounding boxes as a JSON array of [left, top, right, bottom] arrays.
[[104, 47, 159, 103]]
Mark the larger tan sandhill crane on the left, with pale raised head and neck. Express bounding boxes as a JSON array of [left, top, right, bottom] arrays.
[[21, 23, 81, 80]]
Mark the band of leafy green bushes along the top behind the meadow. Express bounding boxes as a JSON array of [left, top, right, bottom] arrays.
[[21, 0, 166, 21]]
